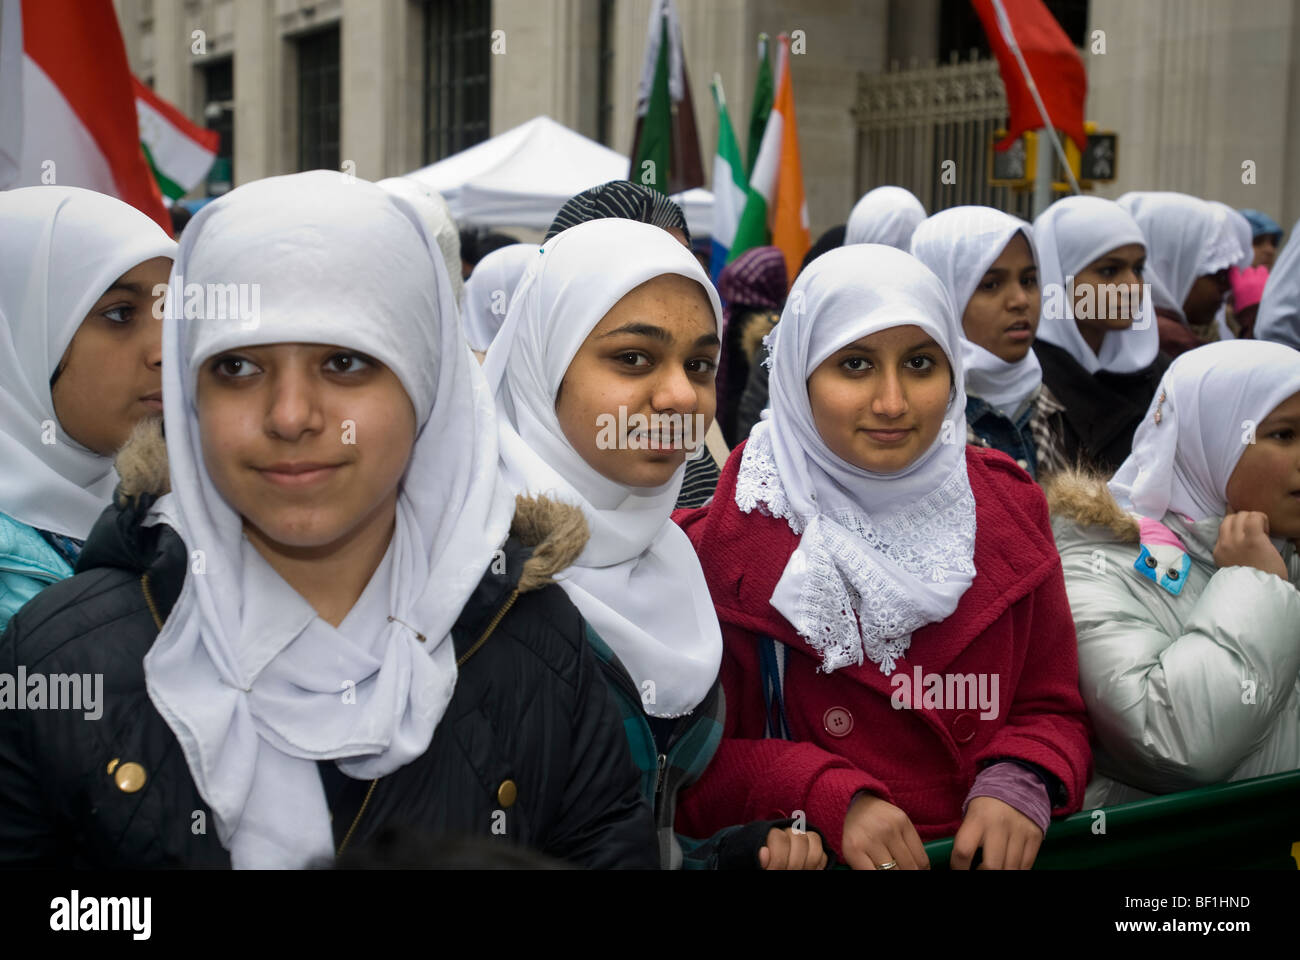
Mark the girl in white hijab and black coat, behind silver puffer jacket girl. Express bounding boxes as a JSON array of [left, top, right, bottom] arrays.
[[1034, 196, 1169, 473]]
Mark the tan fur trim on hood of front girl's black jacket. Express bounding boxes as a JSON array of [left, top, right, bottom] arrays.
[[114, 418, 590, 593]]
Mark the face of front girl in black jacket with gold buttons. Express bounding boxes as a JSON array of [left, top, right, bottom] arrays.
[[196, 343, 416, 557]]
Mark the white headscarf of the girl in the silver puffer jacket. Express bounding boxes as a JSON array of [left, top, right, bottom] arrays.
[[1110, 340, 1300, 522]]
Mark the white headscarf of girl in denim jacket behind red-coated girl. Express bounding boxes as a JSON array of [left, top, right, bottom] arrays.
[[911, 207, 1043, 418]]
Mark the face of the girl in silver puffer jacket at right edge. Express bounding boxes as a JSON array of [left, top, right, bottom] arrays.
[[1226, 393, 1300, 540]]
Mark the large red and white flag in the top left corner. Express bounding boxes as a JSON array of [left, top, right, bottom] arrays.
[[0, 0, 172, 233]]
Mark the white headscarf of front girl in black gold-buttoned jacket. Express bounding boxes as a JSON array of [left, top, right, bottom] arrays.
[[144, 170, 514, 868]]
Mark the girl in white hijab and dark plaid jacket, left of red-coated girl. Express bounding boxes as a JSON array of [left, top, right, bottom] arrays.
[[476, 217, 826, 868]]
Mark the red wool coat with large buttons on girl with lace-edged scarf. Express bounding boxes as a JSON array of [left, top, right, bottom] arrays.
[[673, 444, 1092, 853]]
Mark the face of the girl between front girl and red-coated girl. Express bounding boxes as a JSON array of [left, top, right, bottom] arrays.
[[555, 273, 719, 487]]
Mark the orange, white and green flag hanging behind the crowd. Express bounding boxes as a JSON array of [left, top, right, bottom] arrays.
[[728, 34, 813, 282]]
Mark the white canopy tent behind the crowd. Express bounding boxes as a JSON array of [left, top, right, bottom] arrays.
[[407, 117, 714, 237]]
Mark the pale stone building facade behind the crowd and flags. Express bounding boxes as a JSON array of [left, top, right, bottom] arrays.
[[114, 0, 1300, 235]]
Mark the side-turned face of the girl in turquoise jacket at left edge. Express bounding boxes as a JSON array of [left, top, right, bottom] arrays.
[[51, 256, 172, 457]]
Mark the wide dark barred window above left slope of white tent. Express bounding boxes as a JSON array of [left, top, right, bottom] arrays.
[[424, 0, 491, 164]]
